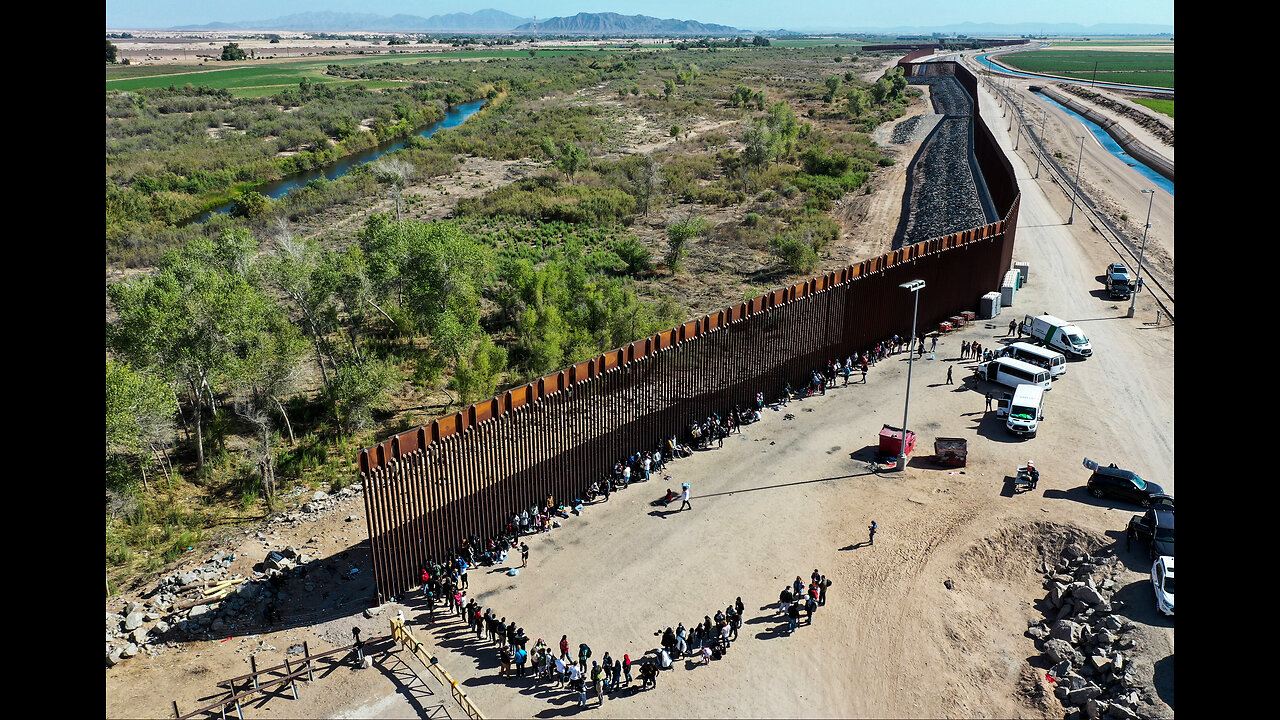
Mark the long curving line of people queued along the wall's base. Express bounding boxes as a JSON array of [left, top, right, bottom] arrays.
[[399, 336, 937, 706]]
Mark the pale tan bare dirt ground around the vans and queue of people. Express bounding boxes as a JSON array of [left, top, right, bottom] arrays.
[[106, 68, 1174, 717]]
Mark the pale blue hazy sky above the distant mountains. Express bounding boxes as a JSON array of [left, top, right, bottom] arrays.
[[106, 0, 1174, 29]]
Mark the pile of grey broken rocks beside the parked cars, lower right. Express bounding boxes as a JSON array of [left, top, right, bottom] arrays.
[[1027, 543, 1151, 720]]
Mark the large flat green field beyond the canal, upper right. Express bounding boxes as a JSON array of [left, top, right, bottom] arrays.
[[997, 50, 1174, 87]]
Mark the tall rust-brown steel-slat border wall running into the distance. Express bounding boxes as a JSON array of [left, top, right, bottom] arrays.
[[356, 63, 1019, 602]]
